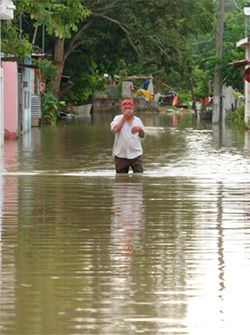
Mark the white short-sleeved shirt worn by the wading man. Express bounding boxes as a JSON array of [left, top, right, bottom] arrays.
[[111, 115, 144, 159]]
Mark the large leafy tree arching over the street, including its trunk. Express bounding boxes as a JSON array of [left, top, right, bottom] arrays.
[[13, 0, 213, 100]]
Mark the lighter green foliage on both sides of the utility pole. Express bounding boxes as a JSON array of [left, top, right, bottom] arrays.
[[193, 0, 245, 96]]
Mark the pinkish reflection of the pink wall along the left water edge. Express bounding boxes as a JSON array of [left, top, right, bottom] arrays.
[[0, 141, 18, 332]]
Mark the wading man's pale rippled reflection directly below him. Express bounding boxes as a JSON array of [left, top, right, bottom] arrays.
[[111, 174, 144, 257]]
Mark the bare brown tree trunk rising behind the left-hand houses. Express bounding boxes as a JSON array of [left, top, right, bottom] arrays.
[[54, 37, 65, 97]]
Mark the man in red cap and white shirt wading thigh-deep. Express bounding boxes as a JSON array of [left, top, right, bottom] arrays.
[[111, 99, 145, 173]]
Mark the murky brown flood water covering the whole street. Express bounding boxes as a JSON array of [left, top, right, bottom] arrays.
[[0, 112, 250, 335]]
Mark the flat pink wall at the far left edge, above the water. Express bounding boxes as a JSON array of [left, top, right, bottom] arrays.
[[2, 62, 18, 139]]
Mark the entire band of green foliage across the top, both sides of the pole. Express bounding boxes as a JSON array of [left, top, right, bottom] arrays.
[[5, 0, 244, 107]]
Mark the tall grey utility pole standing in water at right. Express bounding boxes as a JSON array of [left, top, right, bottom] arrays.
[[212, 0, 224, 123]]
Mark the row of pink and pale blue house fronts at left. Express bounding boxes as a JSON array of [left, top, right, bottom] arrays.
[[2, 56, 41, 139]]
